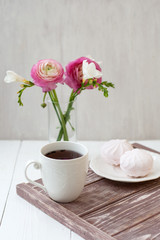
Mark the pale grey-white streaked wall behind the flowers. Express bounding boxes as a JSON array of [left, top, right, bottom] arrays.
[[0, 0, 160, 140]]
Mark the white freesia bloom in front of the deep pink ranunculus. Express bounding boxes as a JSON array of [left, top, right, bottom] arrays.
[[82, 60, 102, 80]]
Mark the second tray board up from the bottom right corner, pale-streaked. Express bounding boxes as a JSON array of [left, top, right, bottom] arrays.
[[83, 181, 160, 236]]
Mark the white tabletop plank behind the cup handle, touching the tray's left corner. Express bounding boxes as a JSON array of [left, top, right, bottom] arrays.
[[0, 141, 70, 240]]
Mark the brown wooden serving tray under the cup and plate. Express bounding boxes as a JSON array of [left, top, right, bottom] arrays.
[[17, 143, 160, 240]]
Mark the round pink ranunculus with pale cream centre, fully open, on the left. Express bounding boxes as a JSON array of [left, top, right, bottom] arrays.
[[31, 59, 64, 92]]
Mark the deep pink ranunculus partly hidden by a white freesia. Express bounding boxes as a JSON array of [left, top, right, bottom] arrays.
[[64, 57, 102, 91]]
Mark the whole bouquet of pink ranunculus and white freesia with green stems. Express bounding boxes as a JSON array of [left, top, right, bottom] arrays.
[[4, 57, 114, 141]]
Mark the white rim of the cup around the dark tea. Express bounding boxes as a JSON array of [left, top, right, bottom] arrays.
[[40, 141, 88, 162]]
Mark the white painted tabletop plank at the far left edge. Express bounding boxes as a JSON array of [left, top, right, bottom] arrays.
[[0, 141, 20, 223]]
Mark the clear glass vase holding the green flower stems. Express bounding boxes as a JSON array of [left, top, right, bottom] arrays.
[[47, 99, 76, 142]]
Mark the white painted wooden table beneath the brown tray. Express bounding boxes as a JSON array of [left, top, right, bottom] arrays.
[[0, 140, 160, 240]]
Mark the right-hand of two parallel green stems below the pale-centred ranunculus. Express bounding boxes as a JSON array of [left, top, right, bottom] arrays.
[[52, 90, 69, 141]]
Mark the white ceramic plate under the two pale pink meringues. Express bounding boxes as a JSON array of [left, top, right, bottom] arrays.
[[90, 152, 160, 182]]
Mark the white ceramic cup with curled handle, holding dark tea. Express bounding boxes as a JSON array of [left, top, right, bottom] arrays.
[[25, 141, 88, 202]]
